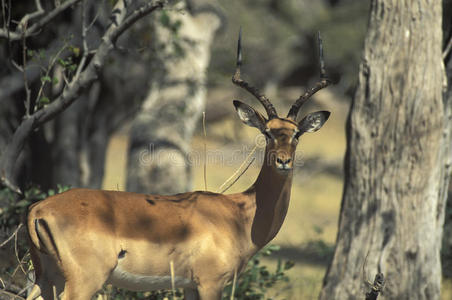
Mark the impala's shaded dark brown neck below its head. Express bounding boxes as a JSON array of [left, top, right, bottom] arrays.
[[245, 149, 292, 250]]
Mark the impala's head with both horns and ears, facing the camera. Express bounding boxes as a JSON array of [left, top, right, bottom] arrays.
[[232, 32, 330, 172]]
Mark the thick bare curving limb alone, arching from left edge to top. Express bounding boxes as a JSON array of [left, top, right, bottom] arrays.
[[0, 0, 163, 191]]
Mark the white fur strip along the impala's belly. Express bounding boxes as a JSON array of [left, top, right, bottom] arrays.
[[108, 266, 196, 291]]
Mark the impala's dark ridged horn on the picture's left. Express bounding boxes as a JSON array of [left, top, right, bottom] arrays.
[[232, 28, 278, 119]]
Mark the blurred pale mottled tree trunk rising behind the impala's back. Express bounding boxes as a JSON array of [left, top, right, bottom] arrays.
[[127, 2, 220, 194]]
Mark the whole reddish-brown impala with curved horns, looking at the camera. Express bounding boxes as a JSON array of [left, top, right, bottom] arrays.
[[27, 34, 330, 300]]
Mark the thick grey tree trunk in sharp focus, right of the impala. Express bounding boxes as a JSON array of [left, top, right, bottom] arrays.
[[320, 0, 451, 300]]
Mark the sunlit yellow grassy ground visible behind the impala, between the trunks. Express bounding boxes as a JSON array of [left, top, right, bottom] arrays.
[[104, 88, 452, 300]]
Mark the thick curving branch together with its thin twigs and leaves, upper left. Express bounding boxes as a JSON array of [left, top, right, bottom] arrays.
[[0, 0, 164, 193]]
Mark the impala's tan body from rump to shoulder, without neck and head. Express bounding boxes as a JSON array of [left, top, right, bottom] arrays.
[[27, 189, 249, 299]]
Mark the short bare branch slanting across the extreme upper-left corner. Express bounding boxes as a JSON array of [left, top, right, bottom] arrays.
[[0, 0, 81, 41]]
